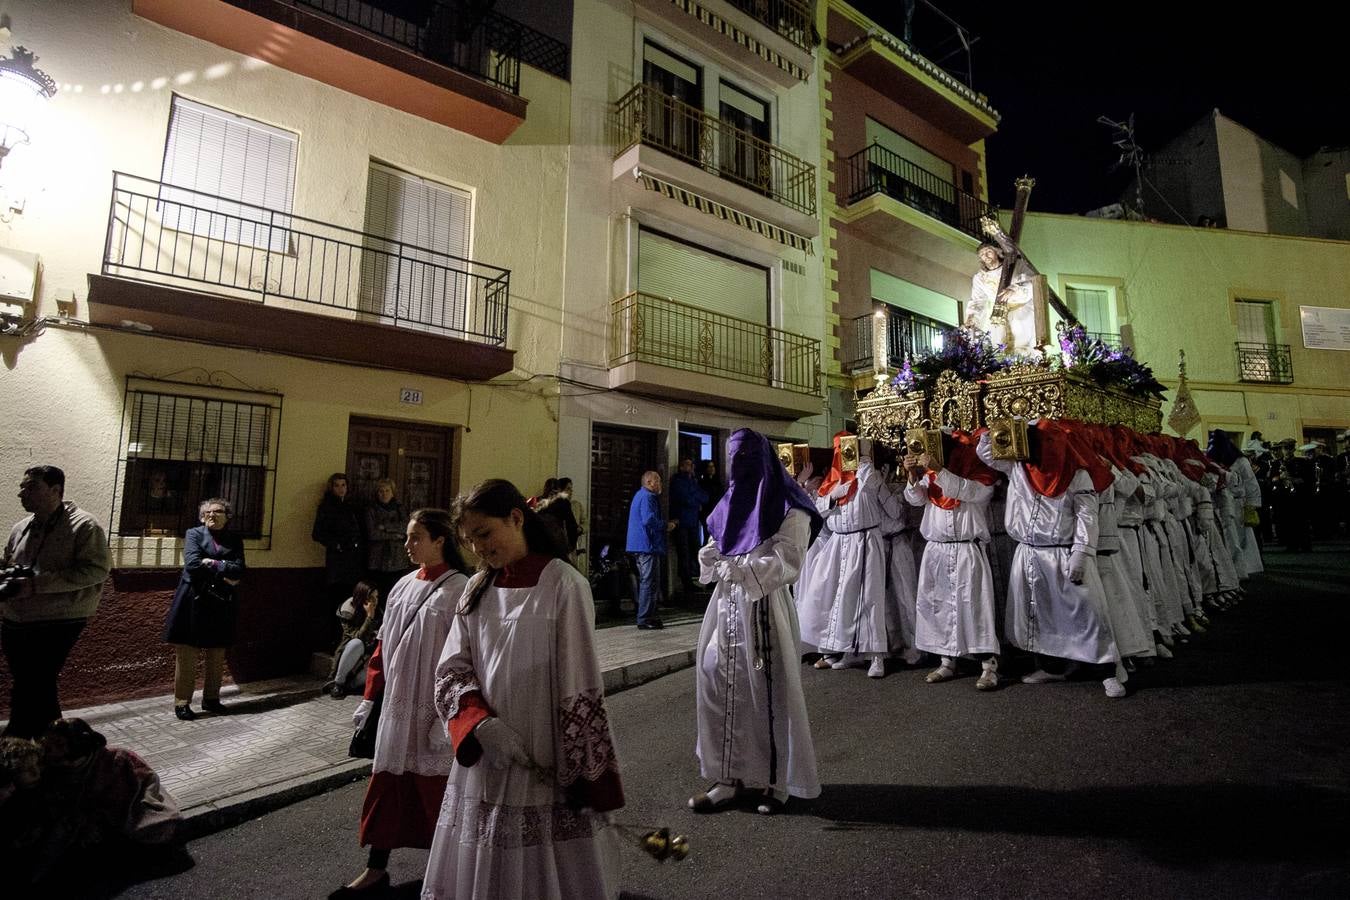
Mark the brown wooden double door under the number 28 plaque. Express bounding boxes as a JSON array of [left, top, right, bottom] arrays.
[[347, 418, 454, 513]]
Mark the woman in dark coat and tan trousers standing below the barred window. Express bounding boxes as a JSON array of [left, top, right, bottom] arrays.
[[165, 497, 244, 721]]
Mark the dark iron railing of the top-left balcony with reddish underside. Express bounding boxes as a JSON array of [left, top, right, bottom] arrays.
[[276, 0, 568, 94]]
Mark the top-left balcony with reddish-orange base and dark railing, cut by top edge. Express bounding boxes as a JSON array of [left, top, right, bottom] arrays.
[[132, 0, 537, 143]]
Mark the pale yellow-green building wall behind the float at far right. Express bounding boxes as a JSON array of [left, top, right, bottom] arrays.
[[1022, 213, 1350, 440]]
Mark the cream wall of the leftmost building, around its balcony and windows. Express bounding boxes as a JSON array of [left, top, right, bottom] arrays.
[[0, 0, 571, 567]]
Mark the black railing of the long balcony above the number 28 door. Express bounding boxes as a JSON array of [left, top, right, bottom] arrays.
[[103, 171, 510, 347]]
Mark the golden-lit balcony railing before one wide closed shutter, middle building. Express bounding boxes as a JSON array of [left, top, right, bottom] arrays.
[[609, 291, 821, 395]]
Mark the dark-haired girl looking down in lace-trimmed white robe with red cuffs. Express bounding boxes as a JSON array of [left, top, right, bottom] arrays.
[[421, 479, 624, 900]]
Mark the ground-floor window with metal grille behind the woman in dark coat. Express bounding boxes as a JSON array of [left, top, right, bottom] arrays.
[[111, 387, 281, 538]]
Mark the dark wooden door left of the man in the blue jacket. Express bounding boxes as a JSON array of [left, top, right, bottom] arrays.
[[590, 425, 664, 563]]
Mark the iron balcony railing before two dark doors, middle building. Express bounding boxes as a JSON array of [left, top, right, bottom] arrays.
[[610, 85, 815, 216]]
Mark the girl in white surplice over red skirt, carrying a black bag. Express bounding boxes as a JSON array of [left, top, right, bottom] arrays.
[[329, 509, 468, 900]]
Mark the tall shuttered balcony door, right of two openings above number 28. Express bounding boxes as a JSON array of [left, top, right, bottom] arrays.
[[360, 162, 473, 333]]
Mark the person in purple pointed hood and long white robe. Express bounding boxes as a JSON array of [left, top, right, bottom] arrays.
[[689, 429, 821, 815]]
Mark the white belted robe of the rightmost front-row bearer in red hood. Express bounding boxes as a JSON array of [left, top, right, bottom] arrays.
[[976, 433, 1123, 669]]
